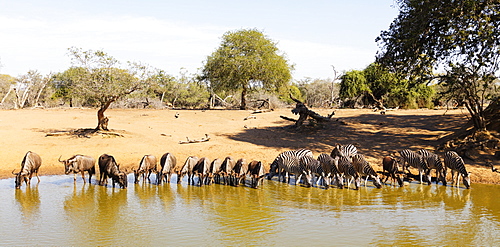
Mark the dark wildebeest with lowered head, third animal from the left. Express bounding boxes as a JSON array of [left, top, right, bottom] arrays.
[[99, 154, 128, 189]]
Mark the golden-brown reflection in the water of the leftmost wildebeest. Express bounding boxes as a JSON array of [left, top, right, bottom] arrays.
[[15, 185, 40, 223]]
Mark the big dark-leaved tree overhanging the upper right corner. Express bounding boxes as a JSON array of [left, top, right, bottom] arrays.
[[377, 0, 500, 131]]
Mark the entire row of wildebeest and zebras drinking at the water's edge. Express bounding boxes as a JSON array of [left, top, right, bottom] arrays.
[[12, 144, 470, 189]]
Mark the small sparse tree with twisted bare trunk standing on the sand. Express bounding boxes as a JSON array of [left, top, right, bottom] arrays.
[[69, 47, 149, 131]]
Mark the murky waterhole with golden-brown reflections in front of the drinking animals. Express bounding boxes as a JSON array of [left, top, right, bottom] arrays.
[[0, 176, 500, 246]]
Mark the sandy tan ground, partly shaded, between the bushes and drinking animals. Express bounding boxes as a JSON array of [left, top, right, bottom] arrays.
[[0, 108, 500, 184]]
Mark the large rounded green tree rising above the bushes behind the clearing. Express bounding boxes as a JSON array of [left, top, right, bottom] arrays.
[[201, 29, 293, 109]]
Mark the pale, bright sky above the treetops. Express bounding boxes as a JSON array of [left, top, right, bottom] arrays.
[[0, 0, 398, 80]]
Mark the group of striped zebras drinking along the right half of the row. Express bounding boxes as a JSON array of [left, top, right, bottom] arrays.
[[267, 144, 470, 189]]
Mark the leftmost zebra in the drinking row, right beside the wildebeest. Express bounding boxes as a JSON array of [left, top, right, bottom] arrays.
[[268, 149, 313, 183]]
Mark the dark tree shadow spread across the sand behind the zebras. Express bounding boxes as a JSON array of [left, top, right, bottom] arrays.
[[228, 114, 466, 157]]
